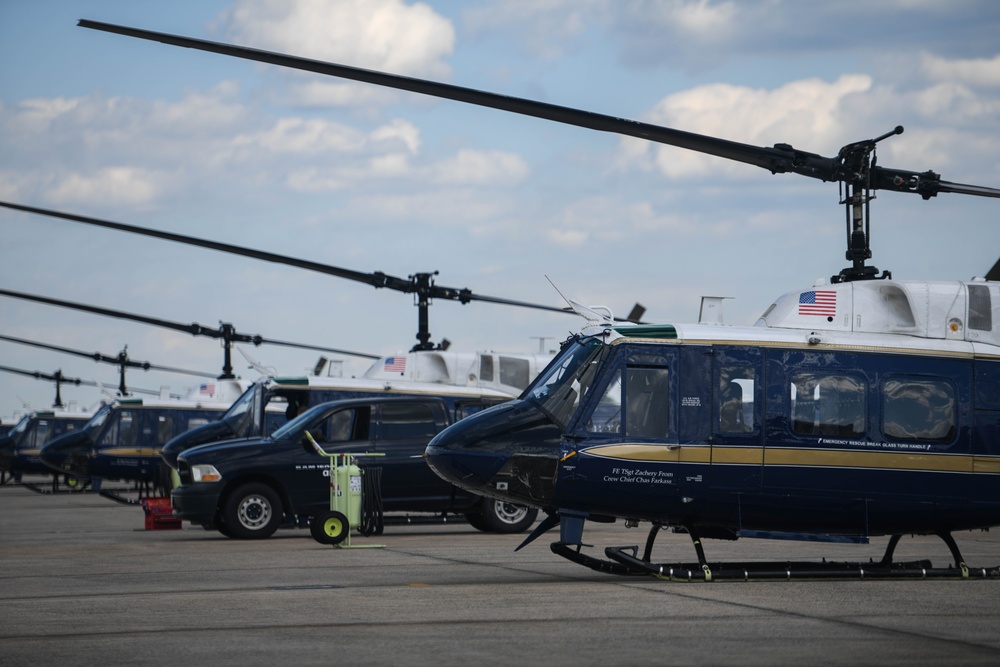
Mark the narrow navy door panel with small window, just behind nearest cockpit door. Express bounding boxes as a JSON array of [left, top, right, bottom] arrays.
[[712, 346, 764, 492]]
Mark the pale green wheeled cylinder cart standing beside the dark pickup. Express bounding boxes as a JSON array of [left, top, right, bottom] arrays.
[[306, 431, 385, 549]]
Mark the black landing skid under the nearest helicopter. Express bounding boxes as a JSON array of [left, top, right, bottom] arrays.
[[551, 523, 1000, 582]]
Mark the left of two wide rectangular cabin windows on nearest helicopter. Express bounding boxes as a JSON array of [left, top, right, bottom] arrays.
[[789, 372, 865, 438]]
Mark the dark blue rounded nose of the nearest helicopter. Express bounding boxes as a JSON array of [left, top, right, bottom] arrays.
[[424, 401, 562, 506]]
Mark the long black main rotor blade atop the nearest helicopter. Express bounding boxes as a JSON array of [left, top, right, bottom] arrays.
[[78, 19, 1000, 199]]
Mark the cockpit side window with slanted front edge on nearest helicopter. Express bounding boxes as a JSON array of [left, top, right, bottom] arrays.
[[588, 366, 670, 439]]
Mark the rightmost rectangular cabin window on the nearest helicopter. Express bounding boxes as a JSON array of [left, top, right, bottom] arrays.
[[882, 379, 957, 442]]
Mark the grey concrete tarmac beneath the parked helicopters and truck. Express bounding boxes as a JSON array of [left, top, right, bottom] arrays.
[[0, 484, 1000, 667]]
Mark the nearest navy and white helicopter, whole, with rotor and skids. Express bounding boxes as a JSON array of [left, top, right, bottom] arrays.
[[79, 20, 1000, 581]]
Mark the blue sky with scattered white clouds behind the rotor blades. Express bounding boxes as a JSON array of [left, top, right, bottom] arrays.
[[0, 0, 1000, 419]]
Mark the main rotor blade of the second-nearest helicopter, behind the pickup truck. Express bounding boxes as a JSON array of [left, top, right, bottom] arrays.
[[0, 201, 569, 318]]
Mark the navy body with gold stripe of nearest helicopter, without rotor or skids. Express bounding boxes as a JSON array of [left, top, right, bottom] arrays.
[[427, 281, 1000, 543]]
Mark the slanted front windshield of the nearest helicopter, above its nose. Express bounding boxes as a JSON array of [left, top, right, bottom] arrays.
[[521, 338, 604, 430]]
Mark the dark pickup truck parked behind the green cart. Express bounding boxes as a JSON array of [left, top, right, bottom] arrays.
[[171, 397, 537, 539]]
